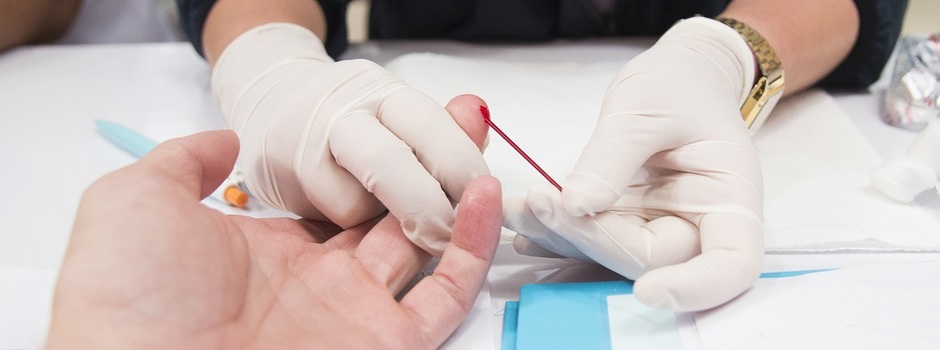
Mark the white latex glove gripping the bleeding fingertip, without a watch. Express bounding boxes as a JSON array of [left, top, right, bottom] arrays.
[[212, 23, 489, 256]]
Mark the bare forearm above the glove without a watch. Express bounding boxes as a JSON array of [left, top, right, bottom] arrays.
[[202, 0, 326, 65]]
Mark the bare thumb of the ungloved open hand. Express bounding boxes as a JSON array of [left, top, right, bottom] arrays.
[[141, 130, 238, 199]]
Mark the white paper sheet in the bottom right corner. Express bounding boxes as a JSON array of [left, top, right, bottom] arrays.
[[680, 261, 940, 350]]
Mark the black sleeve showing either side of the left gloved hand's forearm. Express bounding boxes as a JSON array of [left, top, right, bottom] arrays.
[[176, 0, 349, 59]]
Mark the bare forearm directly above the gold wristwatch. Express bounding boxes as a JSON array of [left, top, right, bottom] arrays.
[[721, 0, 859, 94]]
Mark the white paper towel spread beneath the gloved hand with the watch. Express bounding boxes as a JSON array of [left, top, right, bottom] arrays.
[[386, 53, 940, 252]]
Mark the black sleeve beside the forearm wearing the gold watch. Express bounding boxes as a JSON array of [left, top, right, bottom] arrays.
[[820, 0, 907, 88]]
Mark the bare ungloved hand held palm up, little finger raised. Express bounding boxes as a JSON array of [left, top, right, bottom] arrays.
[[48, 97, 501, 349]]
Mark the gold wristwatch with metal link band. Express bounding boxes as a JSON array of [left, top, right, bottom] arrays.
[[716, 17, 783, 135]]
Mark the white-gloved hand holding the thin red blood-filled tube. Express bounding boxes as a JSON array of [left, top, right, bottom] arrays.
[[504, 18, 763, 311]]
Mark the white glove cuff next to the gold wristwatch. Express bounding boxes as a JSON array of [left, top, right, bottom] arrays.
[[660, 17, 757, 112]]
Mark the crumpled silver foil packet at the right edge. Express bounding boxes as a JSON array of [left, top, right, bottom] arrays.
[[883, 33, 940, 130]]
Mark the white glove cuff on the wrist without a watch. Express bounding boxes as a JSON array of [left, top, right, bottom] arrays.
[[211, 23, 333, 131]]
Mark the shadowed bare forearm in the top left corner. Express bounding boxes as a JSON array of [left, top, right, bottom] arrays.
[[0, 0, 81, 50]]
